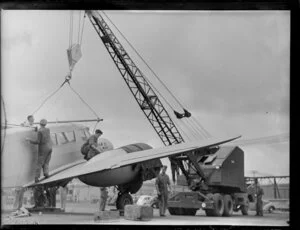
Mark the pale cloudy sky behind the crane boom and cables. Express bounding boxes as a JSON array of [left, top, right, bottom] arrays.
[[1, 10, 290, 175]]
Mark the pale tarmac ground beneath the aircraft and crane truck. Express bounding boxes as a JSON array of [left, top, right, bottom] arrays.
[[1, 202, 290, 226]]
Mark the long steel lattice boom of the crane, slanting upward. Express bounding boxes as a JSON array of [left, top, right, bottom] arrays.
[[86, 11, 184, 145]]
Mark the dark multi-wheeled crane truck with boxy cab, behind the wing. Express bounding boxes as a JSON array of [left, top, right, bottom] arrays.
[[168, 146, 253, 216]]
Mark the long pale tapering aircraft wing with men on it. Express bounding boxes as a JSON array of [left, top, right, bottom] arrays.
[[31, 136, 241, 186]]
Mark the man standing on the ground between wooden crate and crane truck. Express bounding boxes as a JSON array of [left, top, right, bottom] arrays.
[[155, 165, 171, 216]]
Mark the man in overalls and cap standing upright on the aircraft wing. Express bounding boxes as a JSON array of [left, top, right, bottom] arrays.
[[26, 119, 53, 182]]
